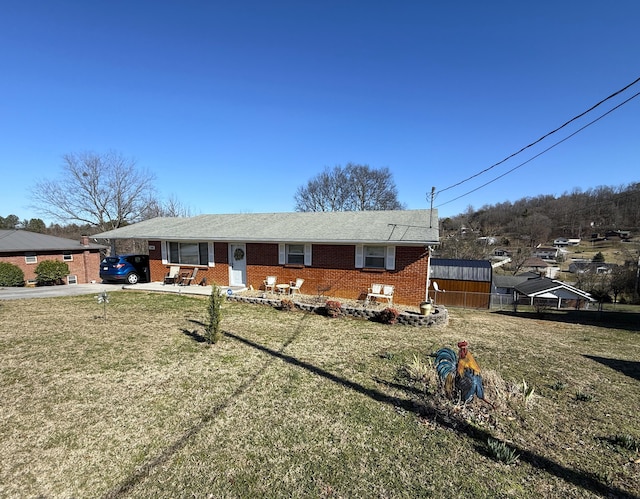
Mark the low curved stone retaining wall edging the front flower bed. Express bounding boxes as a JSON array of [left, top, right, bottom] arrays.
[[227, 294, 449, 327]]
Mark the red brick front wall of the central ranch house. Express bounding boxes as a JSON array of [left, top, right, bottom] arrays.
[[149, 241, 428, 305]]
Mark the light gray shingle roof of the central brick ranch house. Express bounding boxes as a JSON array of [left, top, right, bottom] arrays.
[[92, 210, 439, 245]]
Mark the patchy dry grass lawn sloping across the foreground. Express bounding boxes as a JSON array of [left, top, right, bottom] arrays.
[[0, 292, 640, 498]]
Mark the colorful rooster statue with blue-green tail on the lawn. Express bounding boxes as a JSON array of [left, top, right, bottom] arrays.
[[435, 341, 493, 407]]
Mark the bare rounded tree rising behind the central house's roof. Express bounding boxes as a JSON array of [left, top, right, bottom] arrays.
[[294, 163, 403, 211]]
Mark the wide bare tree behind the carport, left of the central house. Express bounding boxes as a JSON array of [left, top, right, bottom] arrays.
[[32, 151, 154, 231]]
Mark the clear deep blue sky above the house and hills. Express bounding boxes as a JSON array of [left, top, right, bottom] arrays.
[[0, 0, 640, 223]]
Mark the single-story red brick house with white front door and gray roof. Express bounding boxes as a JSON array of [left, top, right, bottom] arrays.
[[93, 210, 439, 304]]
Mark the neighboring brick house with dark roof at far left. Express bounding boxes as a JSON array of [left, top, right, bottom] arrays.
[[0, 229, 108, 284]]
